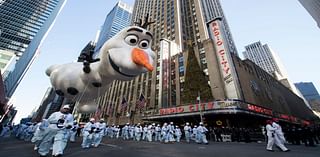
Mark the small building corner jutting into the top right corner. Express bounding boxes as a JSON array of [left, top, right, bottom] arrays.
[[299, 0, 320, 28]]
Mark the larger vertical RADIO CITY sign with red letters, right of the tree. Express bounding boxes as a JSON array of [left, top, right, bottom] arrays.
[[208, 18, 239, 99]]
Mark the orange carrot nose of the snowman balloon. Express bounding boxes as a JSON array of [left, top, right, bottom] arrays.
[[131, 48, 153, 71]]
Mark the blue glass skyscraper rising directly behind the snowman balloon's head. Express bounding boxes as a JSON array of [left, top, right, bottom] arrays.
[[95, 1, 133, 52]]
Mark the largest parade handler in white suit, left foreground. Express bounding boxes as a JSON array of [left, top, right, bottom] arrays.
[[38, 105, 73, 157]]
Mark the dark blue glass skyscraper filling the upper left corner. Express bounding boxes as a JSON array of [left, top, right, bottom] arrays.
[[0, 0, 66, 97]]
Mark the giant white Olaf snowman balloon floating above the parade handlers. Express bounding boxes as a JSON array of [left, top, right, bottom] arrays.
[[46, 20, 155, 113]]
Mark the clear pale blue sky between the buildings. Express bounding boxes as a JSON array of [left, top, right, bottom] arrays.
[[11, 0, 320, 123]]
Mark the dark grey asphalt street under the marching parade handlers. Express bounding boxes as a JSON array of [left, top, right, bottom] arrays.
[[0, 138, 320, 157]]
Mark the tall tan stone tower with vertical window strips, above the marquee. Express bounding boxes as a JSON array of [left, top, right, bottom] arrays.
[[97, 0, 237, 125]]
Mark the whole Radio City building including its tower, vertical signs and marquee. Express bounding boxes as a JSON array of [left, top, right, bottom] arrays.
[[90, 0, 313, 127]]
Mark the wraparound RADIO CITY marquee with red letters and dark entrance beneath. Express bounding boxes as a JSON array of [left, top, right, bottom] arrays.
[[143, 100, 310, 127]]
